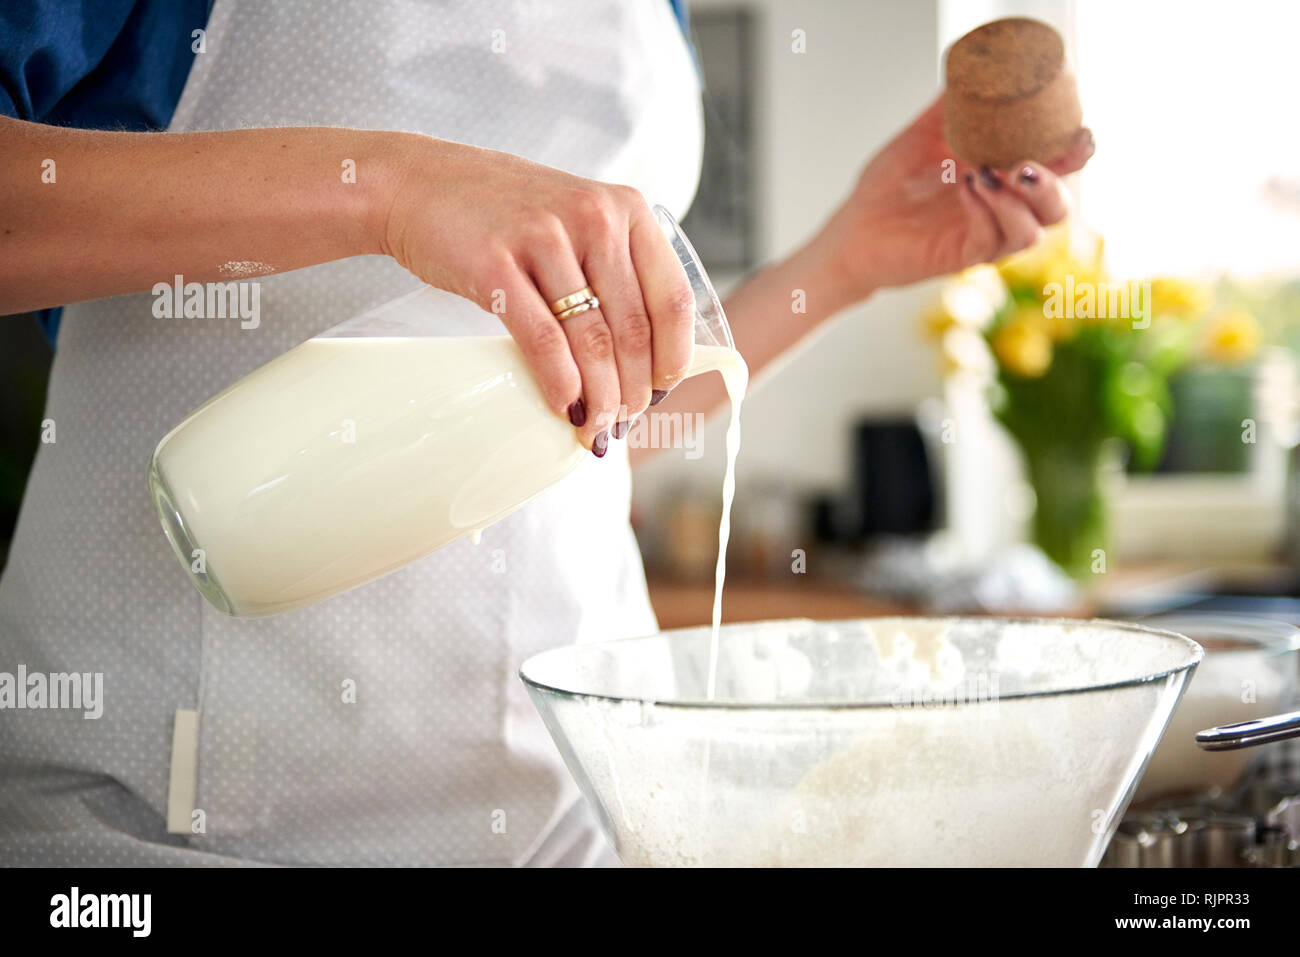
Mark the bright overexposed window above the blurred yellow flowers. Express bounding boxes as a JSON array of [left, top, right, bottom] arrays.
[[1074, 0, 1300, 278]]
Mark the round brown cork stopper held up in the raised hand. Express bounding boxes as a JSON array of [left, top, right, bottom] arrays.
[[944, 17, 1083, 168]]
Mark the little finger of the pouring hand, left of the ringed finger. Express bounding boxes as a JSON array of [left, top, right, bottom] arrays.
[[501, 267, 586, 425]]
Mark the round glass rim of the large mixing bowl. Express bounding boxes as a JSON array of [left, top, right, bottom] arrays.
[[519, 615, 1205, 711]]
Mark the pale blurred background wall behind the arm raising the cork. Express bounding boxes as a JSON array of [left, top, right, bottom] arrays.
[[636, 0, 940, 512]]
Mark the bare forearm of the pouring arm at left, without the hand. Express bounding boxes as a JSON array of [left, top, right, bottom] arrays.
[[0, 117, 406, 315]]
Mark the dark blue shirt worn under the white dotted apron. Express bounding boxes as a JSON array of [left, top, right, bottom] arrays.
[[0, 0, 686, 345]]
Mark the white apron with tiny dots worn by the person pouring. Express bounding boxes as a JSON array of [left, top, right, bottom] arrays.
[[0, 0, 702, 865]]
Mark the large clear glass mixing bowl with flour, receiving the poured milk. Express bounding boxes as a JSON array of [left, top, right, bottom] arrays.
[[520, 619, 1201, 866]]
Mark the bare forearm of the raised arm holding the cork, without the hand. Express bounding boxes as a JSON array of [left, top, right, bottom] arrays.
[[633, 237, 865, 464]]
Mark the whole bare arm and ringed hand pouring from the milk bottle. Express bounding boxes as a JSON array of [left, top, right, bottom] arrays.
[[0, 117, 693, 456]]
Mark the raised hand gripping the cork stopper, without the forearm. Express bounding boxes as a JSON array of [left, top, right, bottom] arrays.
[[814, 96, 1095, 302]]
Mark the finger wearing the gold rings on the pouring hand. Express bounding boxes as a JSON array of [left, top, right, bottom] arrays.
[[529, 221, 620, 456]]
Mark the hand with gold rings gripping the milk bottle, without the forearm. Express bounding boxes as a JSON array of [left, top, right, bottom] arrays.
[[376, 134, 694, 456]]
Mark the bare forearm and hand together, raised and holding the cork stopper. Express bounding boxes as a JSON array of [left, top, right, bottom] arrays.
[[638, 98, 1093, 456]]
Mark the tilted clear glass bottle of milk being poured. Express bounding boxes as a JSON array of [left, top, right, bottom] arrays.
[[150, 207, 744, 618]]
